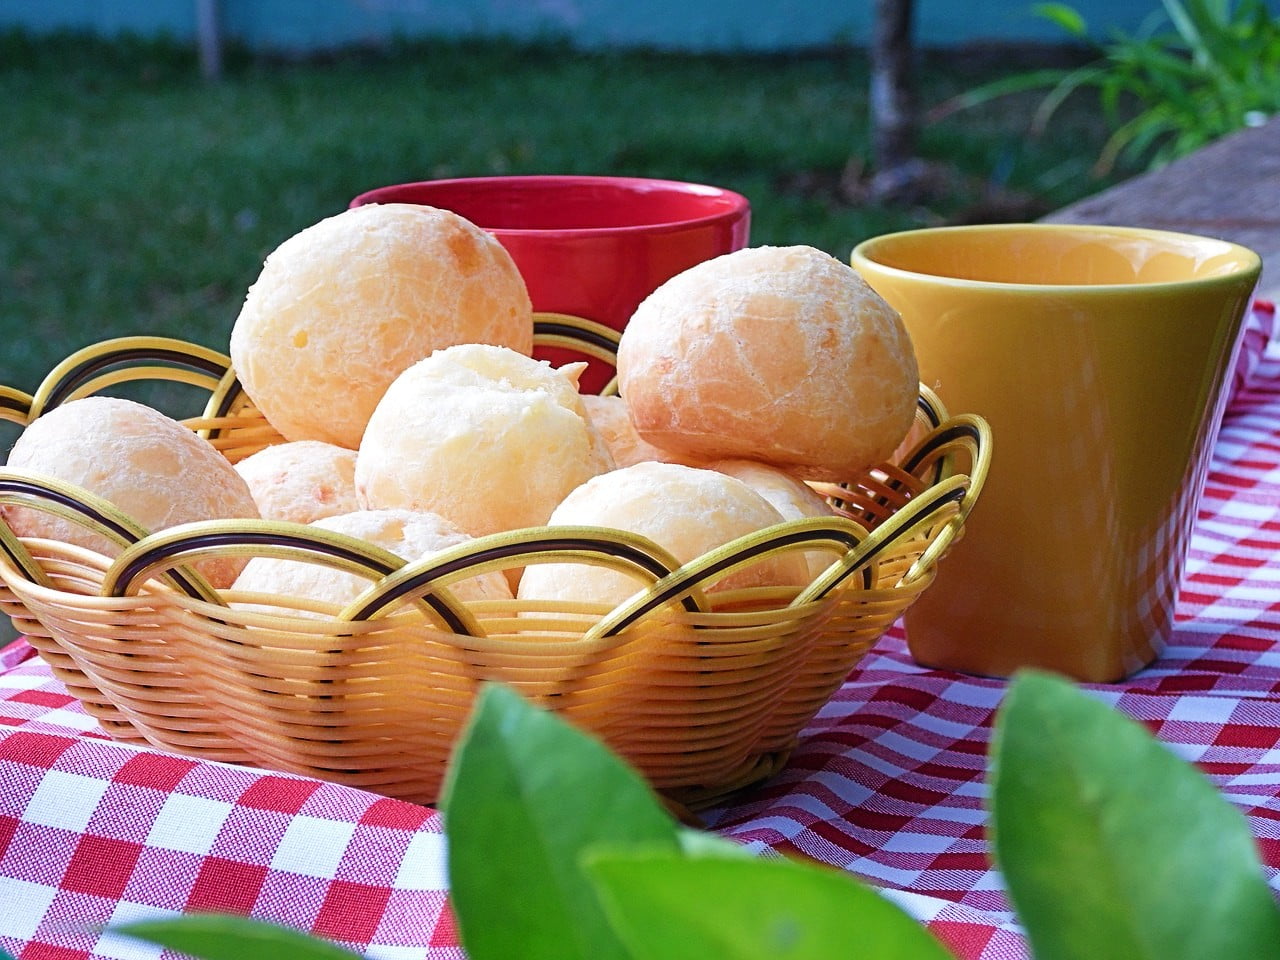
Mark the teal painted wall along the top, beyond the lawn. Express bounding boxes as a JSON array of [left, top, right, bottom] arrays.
[[0, 0, 1228, 52]]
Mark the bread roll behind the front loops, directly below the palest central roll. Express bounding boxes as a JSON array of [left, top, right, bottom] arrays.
[[234, 509, 511, 617]]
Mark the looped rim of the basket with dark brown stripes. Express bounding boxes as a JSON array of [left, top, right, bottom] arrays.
[[0, 330, 991, 647]]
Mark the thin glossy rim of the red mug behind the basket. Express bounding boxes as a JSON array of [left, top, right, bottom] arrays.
[[347, 174, 751, 237]]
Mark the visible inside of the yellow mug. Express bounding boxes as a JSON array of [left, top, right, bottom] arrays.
[[855, 224, 1257, 287]]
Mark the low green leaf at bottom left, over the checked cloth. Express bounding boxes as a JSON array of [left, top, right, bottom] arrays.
[[106, 914, 360, 960]]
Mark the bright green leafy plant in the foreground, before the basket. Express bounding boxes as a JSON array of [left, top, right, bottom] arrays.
[[107, 673, 1280, 960]]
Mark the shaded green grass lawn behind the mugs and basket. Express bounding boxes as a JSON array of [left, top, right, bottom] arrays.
[[0, 35, 1121, 390]]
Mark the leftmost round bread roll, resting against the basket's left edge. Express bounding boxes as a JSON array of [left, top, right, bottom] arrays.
[[4, 397, 259, 588]]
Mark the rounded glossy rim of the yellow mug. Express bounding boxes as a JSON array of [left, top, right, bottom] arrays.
[[849, 223, 1262, 296]]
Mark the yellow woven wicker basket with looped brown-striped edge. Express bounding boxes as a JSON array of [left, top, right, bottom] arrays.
[[0, 315, 991, 806]]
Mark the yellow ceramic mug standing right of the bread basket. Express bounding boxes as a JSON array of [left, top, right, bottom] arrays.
[[852, 224, 1261, 681]]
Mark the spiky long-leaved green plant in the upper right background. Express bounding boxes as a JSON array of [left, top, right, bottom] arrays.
[[933, 0, 1280, 173]]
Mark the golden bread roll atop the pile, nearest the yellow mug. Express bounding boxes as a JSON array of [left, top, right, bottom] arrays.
[[618, 246, 919, 480]]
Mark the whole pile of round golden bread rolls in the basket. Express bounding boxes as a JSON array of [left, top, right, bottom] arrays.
[[4, 204, 918, 616]]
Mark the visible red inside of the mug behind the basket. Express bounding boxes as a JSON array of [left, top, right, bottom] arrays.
[[351, 177, 748, 233]]
